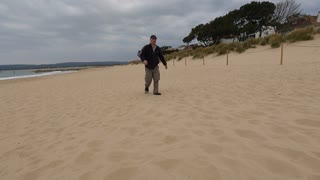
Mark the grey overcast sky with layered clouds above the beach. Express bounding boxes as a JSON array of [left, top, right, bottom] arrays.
[[0, 0, 320, 64]]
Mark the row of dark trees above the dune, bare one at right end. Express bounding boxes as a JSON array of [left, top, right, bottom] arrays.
[[183, 0, 301, 46]]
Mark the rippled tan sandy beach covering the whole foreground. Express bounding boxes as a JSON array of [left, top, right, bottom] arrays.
[[0, 35, 320, 180]]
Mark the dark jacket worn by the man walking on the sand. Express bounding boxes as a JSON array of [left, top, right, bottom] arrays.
[[141, 44, 167, 69]]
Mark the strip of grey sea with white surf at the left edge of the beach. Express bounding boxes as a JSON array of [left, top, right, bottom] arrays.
[[0, 70, 75, 80]]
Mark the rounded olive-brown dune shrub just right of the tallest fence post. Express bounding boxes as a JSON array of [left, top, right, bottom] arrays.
[[286, 28, 315, 43]]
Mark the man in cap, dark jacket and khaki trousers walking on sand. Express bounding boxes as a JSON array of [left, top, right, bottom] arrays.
[[140, 35, 168, 95]]
